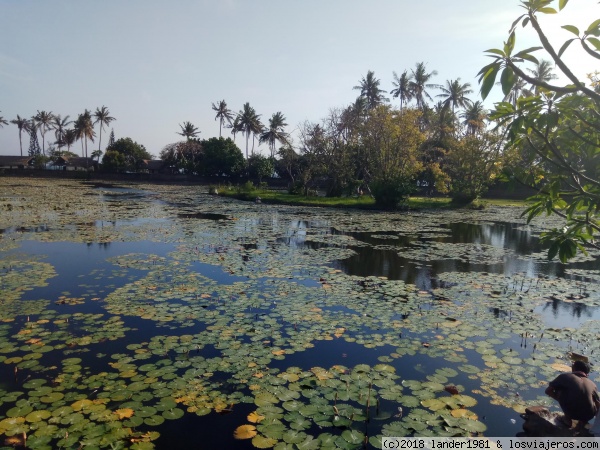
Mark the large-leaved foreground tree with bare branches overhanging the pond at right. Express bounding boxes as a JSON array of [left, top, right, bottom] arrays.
[[479, 0, 600, 262]]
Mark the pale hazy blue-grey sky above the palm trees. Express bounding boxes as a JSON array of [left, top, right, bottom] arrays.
[[0, 0, 600, 155]]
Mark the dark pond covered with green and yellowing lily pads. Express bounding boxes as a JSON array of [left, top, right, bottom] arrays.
[[0, 178, 600, 449]]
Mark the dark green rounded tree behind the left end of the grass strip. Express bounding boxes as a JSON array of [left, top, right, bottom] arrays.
[[199, 137, 245, 177]]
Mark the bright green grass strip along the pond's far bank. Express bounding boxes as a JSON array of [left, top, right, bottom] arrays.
[[217, 187, 526, 209]]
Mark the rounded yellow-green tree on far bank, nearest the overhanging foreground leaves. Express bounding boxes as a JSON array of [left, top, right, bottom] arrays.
[[446, 132, 504, 203]]
